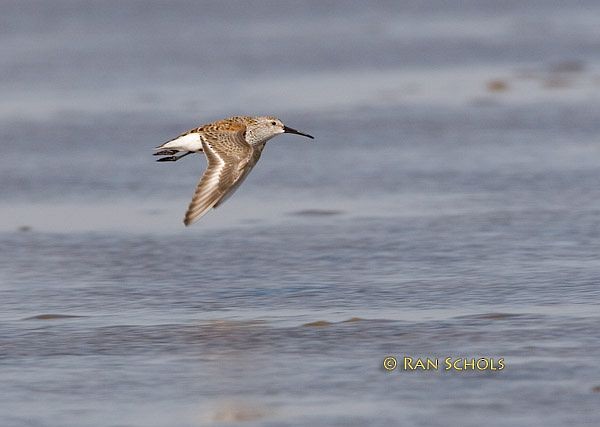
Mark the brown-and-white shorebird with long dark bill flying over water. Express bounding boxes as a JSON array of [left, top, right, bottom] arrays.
[[154, 116, 314, 227]]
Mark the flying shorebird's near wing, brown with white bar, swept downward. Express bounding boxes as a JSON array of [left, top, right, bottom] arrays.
[[183, 124, 256, 225]]
